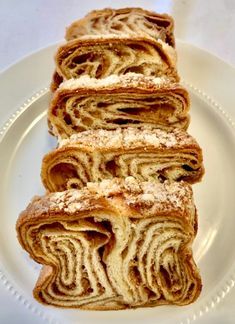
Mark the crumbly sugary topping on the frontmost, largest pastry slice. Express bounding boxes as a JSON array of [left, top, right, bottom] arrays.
[[40, 177, 194, 213]]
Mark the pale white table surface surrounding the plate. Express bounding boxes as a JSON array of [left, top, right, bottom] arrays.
[[0, 0, 235, 324]]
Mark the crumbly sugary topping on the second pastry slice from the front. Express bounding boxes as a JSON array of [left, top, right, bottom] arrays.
[[59, 126, 198, 149]]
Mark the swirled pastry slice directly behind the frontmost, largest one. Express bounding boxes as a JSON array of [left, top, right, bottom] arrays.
[[41, 128, 204, 191]]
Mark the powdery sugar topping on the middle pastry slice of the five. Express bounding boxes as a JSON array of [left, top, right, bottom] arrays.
[[57, 72, 175, 91]]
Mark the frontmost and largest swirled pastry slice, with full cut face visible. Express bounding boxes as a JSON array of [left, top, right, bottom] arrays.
[[16, 177, 202, 310]]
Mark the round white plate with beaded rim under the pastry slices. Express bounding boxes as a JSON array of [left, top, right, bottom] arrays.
[[0, 42, 235, 324]]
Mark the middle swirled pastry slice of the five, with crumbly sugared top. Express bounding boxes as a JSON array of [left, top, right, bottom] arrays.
[[48, 73, 189, 138]]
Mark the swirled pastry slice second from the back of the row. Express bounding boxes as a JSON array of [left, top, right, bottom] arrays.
[[51, 35, 179, 90]]
